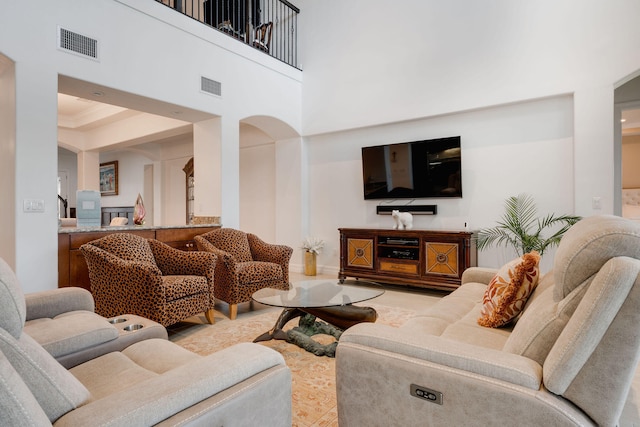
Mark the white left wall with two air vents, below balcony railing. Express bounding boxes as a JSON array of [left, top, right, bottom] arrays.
[[0, 0, 301, 291]]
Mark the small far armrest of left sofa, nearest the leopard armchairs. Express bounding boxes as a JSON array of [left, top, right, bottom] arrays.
[[24, 287, 95, 320]]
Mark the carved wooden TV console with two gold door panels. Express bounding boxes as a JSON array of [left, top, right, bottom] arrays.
[[339, 228, 477, 290]]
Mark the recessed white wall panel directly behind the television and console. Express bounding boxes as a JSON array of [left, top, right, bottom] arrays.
[[308, 96, 574, 272]]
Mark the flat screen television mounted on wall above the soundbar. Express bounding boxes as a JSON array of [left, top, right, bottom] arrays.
[[362, 136, 462, 200]]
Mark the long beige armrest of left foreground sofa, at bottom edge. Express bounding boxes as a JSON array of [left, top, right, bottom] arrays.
[[54, 343, 287, 427]]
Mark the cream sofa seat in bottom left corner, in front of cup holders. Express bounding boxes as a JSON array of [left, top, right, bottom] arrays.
[[0, 259, 291, 426]]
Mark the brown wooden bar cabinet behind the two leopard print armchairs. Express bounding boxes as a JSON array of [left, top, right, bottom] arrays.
[[58, 225, 219, 290]]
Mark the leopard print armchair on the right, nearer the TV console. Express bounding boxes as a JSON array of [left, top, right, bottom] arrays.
[[194, 228, 293, 320]]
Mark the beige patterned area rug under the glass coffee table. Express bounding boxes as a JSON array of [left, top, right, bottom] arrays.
[[169, 304, 413, 427]]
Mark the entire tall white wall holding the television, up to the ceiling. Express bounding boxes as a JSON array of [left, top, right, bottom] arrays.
[[298, 0, 640, 270]]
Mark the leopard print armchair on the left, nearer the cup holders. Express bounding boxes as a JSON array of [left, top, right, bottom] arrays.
[[80, 233, 217, 326]]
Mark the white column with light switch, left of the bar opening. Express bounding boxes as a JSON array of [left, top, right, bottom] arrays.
[[10, 61, 58, 292]]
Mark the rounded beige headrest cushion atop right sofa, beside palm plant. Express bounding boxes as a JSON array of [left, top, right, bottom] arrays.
[[553, 215, 640, 301]]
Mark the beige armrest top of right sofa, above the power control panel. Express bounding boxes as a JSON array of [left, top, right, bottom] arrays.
[[336, 323, 542, 390]]
